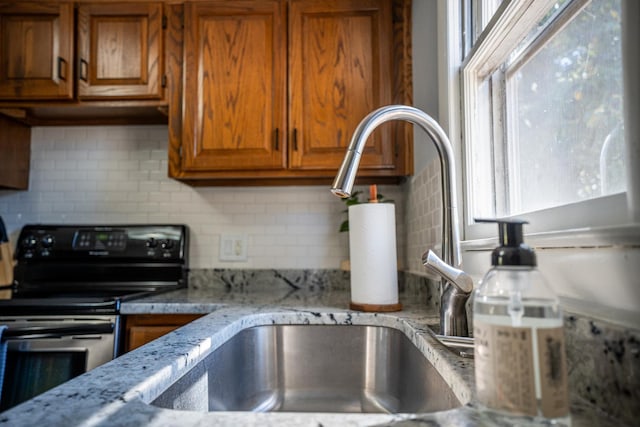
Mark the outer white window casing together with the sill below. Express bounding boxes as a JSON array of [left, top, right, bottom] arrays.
[[436, 0, 640, 329]]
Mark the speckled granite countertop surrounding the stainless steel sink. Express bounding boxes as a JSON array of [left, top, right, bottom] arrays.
[[0, 296, 480, 426]]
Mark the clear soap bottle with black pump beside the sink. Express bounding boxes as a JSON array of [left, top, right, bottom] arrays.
[[473, 219, 571, 425]]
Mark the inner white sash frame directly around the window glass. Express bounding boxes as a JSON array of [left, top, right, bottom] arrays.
[[460, 0, 640, 247]]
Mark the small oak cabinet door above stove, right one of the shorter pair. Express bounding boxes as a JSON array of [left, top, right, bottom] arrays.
[[78, 2, 164, 99]]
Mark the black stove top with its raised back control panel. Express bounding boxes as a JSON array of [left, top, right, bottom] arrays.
[[0, 224, 188, 316]]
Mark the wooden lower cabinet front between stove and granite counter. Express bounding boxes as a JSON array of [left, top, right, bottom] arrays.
[[124, 314, 204, 352]]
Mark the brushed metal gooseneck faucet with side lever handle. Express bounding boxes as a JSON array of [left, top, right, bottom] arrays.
[[331, 105, 473, 337]]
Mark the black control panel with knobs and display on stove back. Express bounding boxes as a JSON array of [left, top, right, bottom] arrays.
[[16, 224, 188, 262]]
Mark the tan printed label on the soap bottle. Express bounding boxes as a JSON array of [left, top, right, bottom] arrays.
[[473, 321, 569, 418]]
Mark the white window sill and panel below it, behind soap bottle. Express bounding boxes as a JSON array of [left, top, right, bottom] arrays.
[[461, 224, 640, 330]]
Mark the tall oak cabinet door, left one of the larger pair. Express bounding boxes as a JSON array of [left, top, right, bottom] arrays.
[[182, 0, 286, 172]]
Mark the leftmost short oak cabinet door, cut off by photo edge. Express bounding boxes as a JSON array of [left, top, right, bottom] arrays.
[[0, 2, 73, 100]]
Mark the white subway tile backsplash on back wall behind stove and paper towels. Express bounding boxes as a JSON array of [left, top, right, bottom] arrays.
[[0, 126, 404, 268]]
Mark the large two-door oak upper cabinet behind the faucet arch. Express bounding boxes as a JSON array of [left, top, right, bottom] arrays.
[[170, 0, 411, 184]]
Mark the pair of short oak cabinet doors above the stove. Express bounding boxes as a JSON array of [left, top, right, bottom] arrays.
[[0, 2, 164, 101]]
